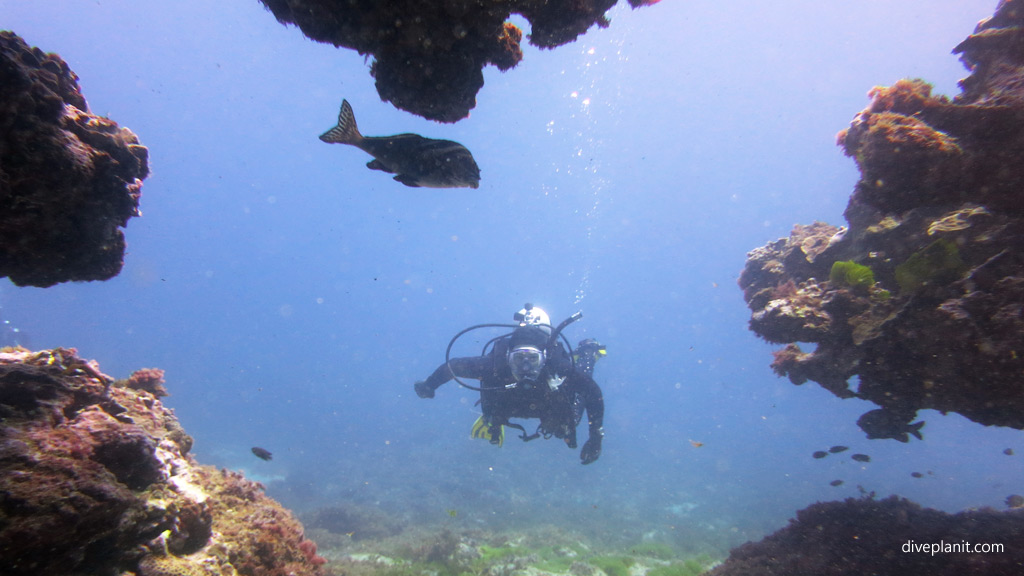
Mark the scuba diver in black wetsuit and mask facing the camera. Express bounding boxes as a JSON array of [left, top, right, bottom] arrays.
[[414, 303, 605, 464]]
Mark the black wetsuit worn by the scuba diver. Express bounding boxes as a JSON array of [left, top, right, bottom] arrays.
[[418, 337, 604, 450]]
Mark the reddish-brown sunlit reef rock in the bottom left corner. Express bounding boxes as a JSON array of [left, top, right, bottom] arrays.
[[0, 348, 325, 576]]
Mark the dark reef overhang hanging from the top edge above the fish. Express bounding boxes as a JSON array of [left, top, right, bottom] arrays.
[[260, 0, 657, 122]]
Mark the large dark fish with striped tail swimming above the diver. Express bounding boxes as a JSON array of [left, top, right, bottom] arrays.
[[321, 100, 480, 188]]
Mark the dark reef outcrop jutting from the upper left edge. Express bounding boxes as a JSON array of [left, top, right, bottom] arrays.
[[0, 32, 148, 287]]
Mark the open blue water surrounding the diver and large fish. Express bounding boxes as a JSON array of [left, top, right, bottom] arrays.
[[0, 0, 1024, 549]]
